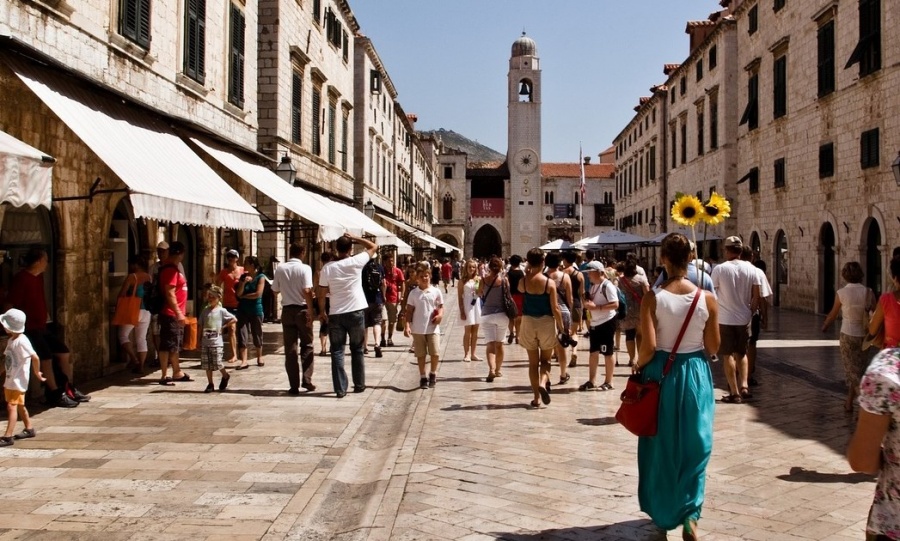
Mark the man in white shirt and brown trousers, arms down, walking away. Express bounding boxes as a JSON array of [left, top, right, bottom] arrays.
[[272, 242, 316, 395]]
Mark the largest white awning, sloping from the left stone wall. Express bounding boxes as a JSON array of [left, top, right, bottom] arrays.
[[11, 62, 263, 231]]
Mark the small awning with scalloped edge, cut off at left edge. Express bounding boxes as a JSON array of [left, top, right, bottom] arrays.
[[0, 131, 56, 209]]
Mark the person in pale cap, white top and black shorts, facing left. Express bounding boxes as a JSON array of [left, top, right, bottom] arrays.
[[578, 260, 619, 391]]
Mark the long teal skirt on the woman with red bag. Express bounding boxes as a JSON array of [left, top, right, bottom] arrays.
[[638, 351, 715, 530]]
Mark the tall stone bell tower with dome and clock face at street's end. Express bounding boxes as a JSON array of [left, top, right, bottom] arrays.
[[506, 32, 543, 257]]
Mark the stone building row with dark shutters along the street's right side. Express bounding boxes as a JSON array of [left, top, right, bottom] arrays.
[[616, 0, 900, 313]]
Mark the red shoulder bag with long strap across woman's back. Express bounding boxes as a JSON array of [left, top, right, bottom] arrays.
[[616, 288, 703, 436]]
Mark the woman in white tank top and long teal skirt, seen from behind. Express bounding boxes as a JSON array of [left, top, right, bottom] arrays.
[[634, 233, 719, 540]]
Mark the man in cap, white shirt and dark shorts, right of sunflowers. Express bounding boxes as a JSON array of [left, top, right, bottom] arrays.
[[712, 236, 760, 404]]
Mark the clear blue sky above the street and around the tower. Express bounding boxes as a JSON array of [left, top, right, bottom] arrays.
[[350, 0, 721, 162]]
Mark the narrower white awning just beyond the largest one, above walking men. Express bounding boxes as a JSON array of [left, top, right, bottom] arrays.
[[191, 139, 347, 242]]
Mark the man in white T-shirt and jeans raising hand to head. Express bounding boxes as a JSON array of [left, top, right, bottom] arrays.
[[318, 233, 378, 398]]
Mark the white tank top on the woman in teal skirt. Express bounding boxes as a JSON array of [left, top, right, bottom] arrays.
[[654, 289, 709, 353]]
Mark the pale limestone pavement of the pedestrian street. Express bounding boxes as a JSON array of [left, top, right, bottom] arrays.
[[0, 289, 874, 541]]
